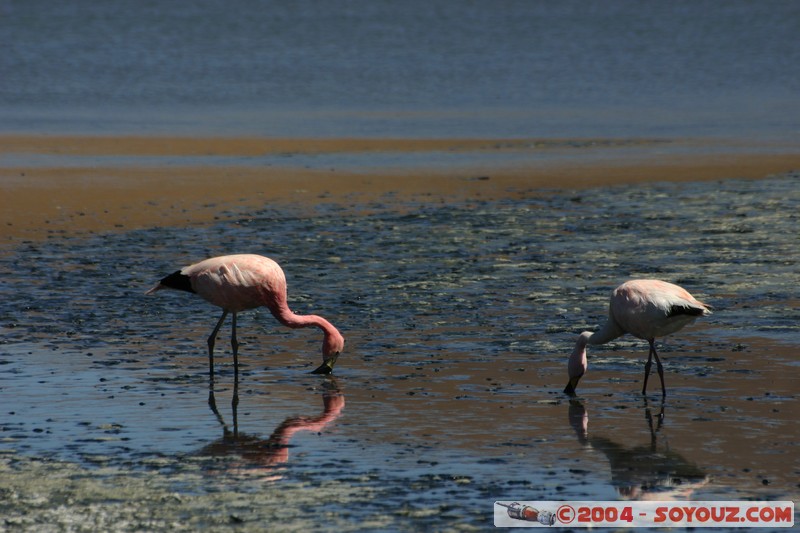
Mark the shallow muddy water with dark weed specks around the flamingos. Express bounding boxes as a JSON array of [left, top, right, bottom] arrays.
[[0, 175, 800, 531]]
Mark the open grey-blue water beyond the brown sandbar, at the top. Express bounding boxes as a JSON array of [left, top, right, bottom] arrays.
[[0, 0, 800, 138]]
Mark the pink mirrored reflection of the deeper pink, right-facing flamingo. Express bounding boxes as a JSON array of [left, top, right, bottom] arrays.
[[197, 376, 344, 481]]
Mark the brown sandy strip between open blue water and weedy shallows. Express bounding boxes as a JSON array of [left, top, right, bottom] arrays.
[[0, 135, 800, 244]]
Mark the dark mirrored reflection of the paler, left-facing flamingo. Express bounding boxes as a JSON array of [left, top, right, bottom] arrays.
[[569, 399, 710, 501]]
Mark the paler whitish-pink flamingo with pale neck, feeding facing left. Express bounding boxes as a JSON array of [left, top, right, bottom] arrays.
[[564, 279, 711, 398]]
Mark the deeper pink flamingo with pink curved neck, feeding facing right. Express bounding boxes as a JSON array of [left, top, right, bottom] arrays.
[[146, 254, 344, 374]]
